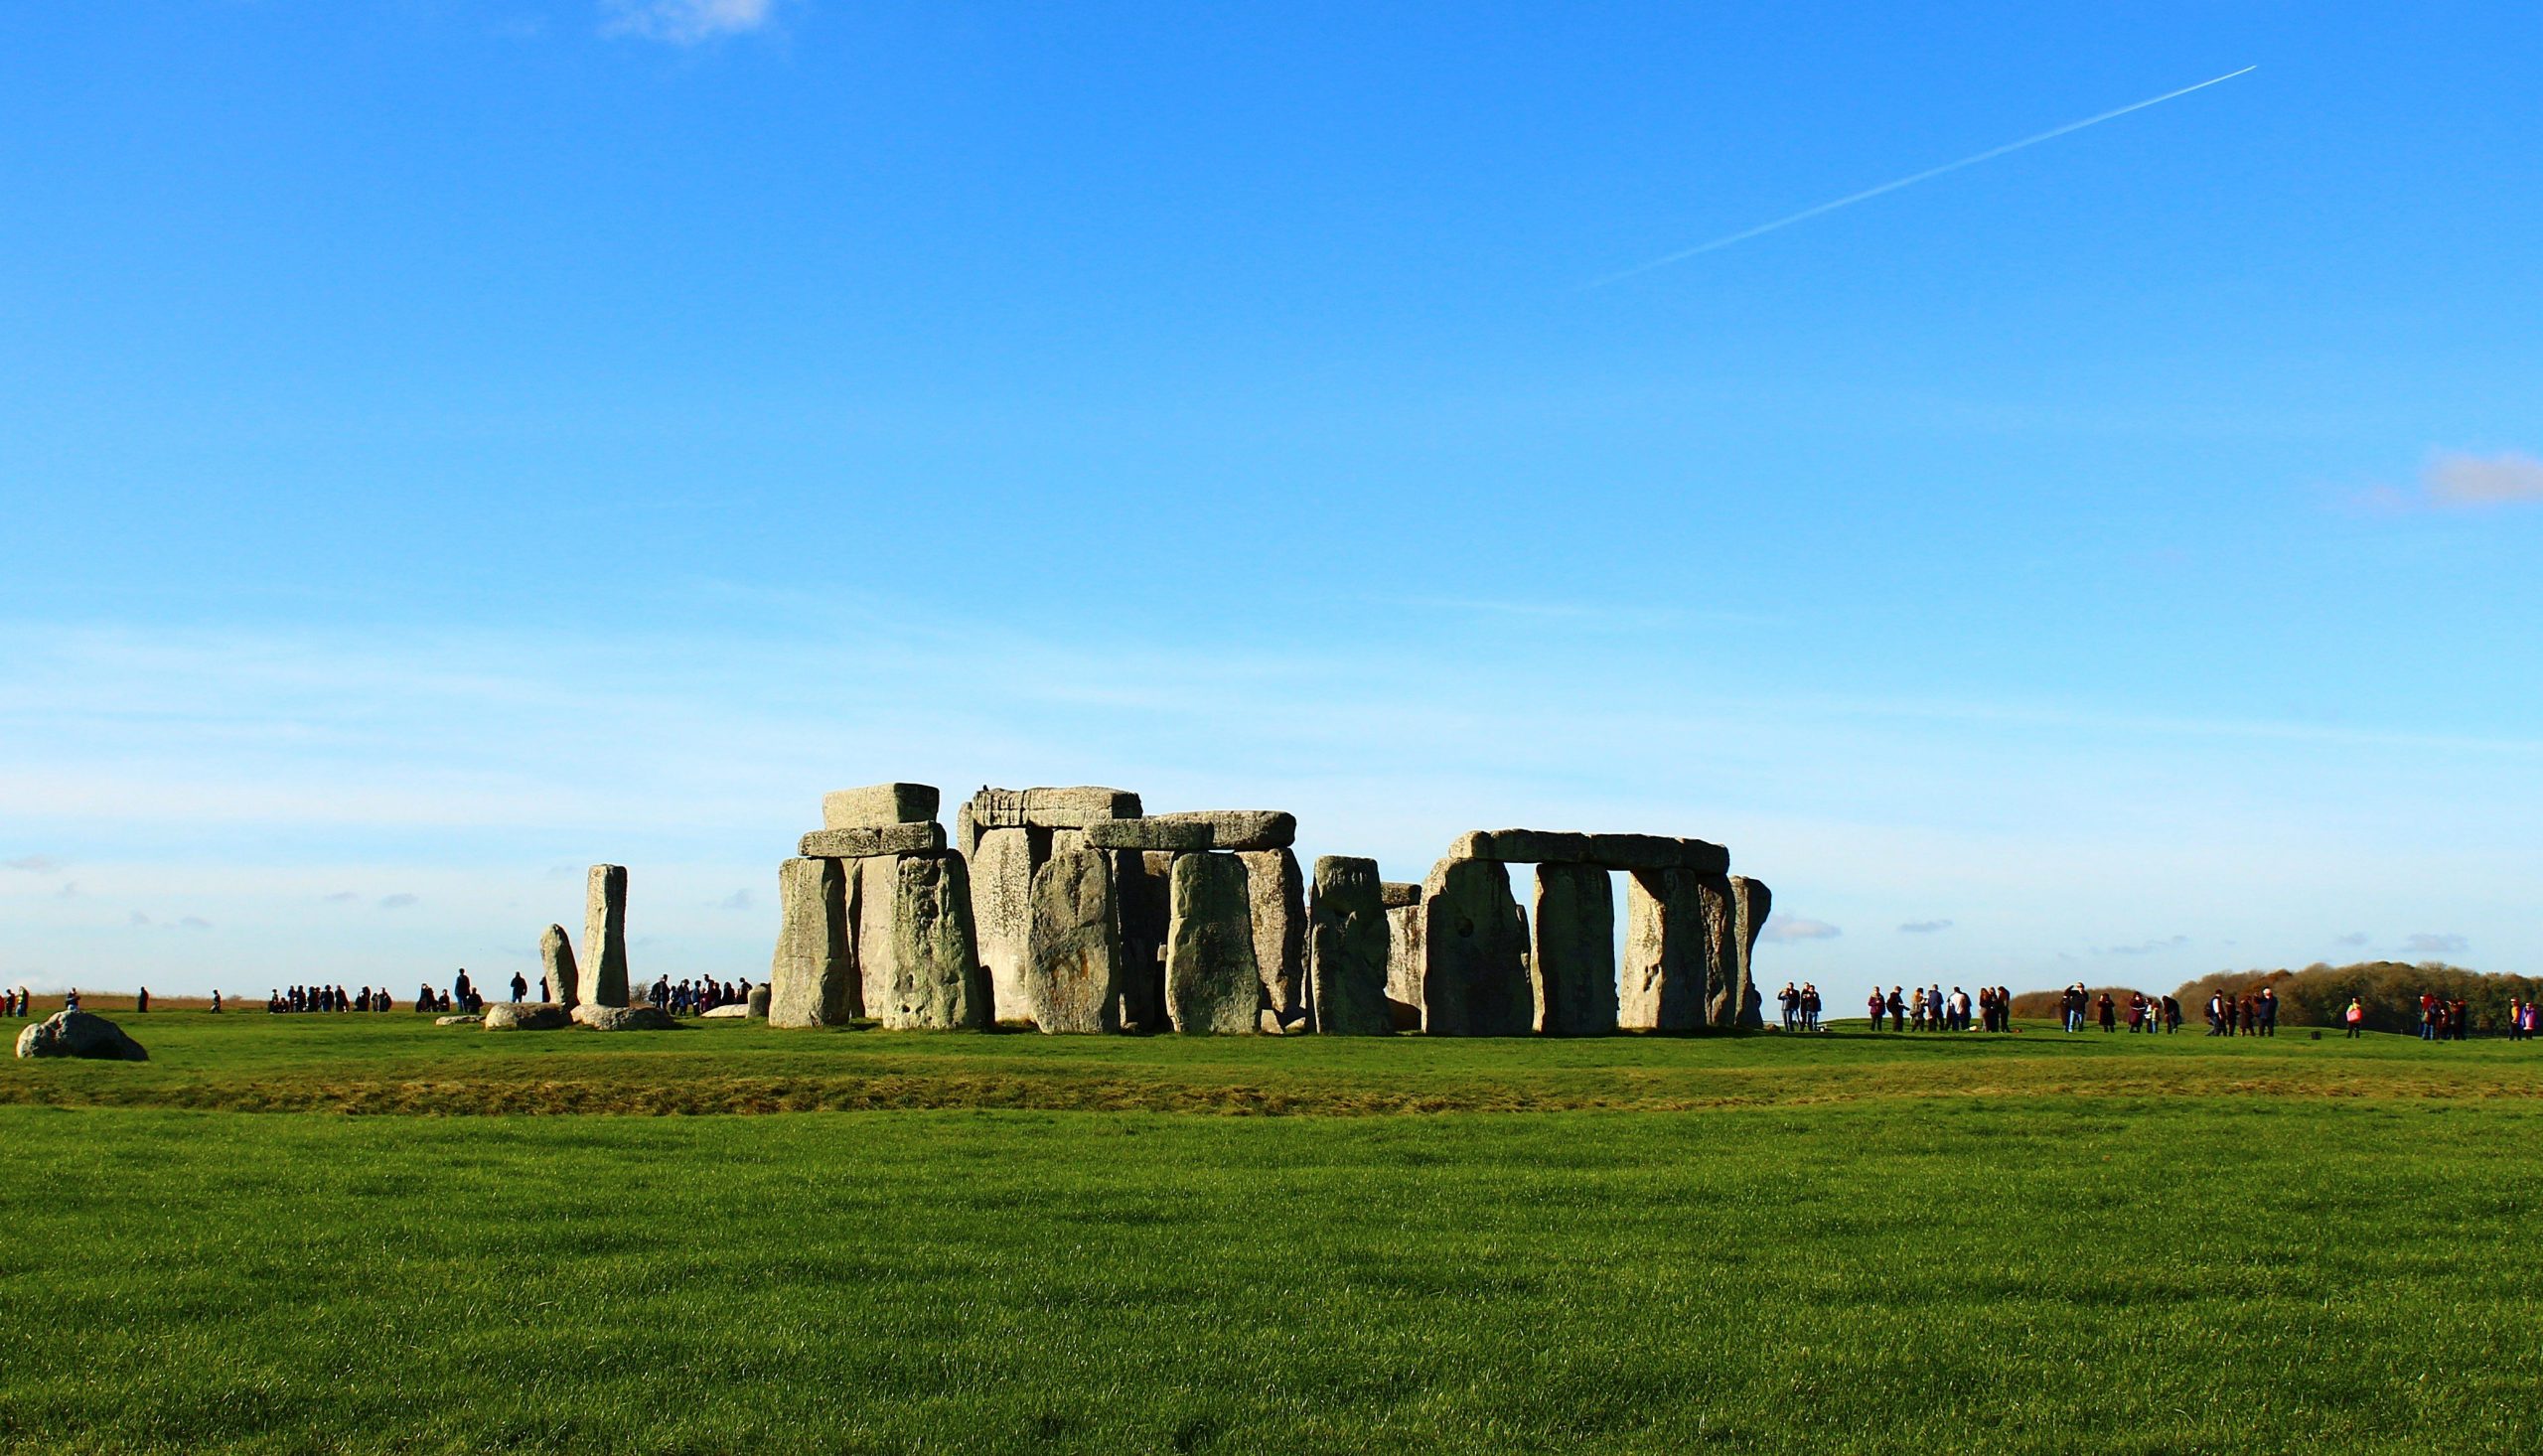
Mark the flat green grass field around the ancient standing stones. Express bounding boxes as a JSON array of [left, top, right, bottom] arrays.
[[0, 1014, 2543, 1451]]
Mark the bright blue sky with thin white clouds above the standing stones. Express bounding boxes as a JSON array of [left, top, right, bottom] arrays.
[[0, 0, 2543, 993]]
